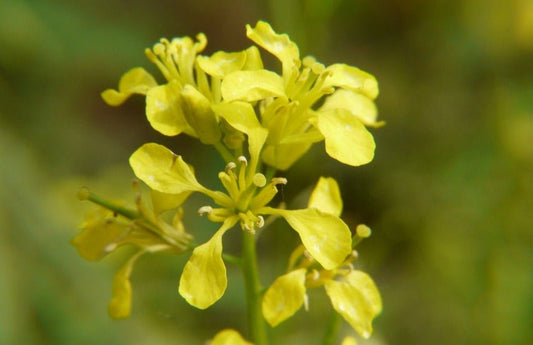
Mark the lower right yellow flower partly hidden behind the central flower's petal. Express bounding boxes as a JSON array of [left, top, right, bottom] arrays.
[[263, 178, 381, 338]]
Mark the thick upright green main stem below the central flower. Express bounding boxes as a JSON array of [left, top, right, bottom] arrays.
[[242, 231, 268, 345]]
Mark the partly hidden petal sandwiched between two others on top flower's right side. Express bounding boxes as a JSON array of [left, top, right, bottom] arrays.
[[320, 89, 383, 127]]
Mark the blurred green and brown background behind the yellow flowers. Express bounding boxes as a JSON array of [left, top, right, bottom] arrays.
[[0, 0, 533, 345]]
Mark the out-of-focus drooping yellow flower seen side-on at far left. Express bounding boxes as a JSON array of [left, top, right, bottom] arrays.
[[71, 185, 192, 318]]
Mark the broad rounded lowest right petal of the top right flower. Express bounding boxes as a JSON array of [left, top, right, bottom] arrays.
[[316, 109, 376, 166]]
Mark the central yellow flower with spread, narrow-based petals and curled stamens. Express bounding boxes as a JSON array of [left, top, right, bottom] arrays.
[[130, 141, 351, 309]]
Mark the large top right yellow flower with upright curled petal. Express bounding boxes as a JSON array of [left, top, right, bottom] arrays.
[[221, 21, 382, 170]]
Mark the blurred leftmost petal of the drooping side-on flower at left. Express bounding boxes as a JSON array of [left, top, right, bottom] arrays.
[[71, 208, 131, 261]]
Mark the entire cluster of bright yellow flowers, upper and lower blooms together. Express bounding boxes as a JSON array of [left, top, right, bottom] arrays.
[[73, 21, 382, 344]]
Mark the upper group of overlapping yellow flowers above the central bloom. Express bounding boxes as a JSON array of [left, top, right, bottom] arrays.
[[102, 21, 383, 170]]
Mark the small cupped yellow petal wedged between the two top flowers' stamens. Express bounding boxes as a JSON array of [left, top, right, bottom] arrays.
[[196, 51, 247, 79]]
